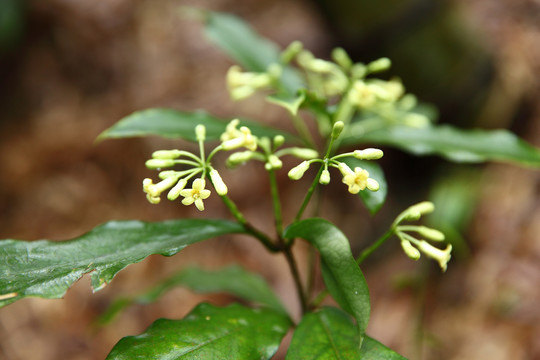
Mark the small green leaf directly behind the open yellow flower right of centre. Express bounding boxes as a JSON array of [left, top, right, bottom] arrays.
[[342, 157, 388, 215]]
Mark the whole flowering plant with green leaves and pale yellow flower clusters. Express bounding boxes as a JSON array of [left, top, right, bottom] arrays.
[[0, 12, 540, 360]]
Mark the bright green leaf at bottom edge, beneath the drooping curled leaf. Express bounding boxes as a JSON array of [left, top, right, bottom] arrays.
[[286, 307, 405, 360]]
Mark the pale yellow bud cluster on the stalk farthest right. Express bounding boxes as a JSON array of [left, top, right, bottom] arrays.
[[393, 201, 452, 271]]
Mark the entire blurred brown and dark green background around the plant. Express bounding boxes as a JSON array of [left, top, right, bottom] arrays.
[[0, 0, 540, 360]]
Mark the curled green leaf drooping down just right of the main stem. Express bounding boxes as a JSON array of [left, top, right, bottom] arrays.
[[285, 218, 371, 334]]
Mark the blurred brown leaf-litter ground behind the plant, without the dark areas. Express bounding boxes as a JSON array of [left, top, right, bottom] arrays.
[[0, 0, 540, 360]]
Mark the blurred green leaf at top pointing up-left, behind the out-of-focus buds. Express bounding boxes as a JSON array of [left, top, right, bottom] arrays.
[[204, 12, 302, 95]]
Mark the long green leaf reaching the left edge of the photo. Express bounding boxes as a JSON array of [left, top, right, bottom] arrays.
[[0, 219, 244, 306]]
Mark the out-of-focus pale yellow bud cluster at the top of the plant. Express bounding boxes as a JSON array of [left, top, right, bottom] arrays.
[[227, 41, 431, 127]]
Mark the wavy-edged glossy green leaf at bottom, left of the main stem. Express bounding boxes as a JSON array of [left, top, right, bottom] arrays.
[[107, 303, 291, 360]]
